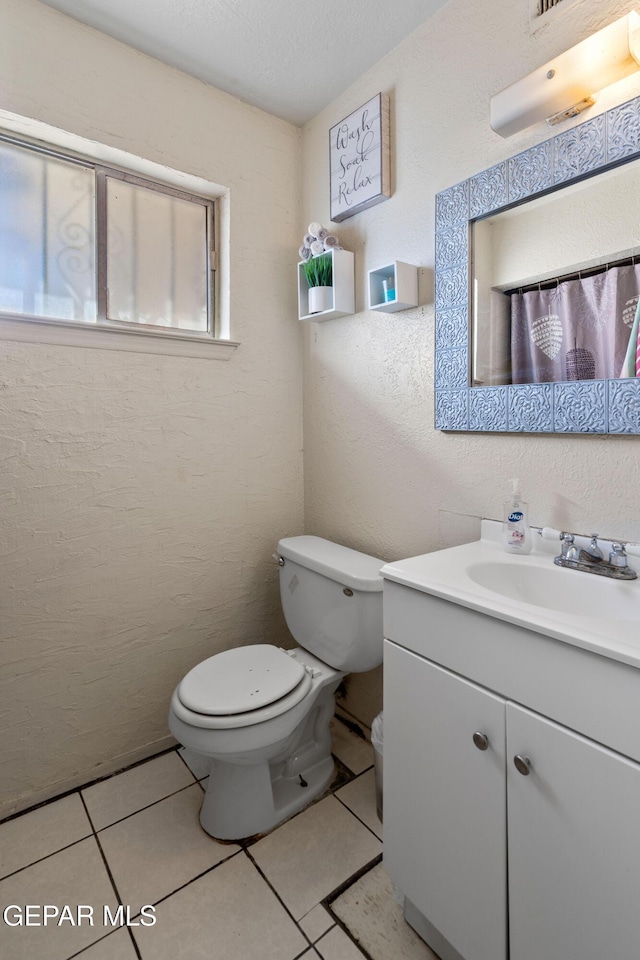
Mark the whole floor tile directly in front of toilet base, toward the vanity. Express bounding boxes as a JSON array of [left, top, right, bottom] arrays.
[[250, 797, 382, 920]]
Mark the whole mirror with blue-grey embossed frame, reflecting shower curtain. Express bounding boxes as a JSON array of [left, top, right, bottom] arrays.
[[435, 98, 640, 434]]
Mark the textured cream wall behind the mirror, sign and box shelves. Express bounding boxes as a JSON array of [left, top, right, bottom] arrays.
[[303, 0, 640, 720]]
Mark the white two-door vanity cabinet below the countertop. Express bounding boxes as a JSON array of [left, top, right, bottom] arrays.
[[384, 582, 640, 960]]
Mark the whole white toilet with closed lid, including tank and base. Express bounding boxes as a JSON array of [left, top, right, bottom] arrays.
[[169, 536, 383, 840]]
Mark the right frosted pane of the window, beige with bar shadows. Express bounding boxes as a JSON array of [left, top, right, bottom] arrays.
[[107, 177, 208, 333]]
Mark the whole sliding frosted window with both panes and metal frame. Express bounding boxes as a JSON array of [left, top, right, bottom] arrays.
[[0, 131, 215, 339]]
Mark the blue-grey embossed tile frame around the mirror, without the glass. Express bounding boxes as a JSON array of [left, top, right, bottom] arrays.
[[435, 97, 640, 434]]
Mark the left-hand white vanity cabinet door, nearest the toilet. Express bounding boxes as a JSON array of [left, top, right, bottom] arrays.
[[384, 641, 508, 960]]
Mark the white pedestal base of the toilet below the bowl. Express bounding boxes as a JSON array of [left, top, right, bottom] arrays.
[[200, 681, 337, 842]]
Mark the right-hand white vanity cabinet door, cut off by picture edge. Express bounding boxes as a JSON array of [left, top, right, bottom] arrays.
[[507, 704, 640, 960]]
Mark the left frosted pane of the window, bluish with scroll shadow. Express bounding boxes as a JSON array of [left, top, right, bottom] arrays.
[[0, 142, 96, 322]]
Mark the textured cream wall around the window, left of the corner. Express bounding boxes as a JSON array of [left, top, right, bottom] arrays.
[[0, 0, 303, 815]]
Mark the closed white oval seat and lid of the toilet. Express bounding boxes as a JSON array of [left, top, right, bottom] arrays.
[[174, 644, 312, 729]]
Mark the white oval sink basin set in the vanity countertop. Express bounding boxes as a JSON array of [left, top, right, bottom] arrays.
[[466, 557, 640, 620]]
